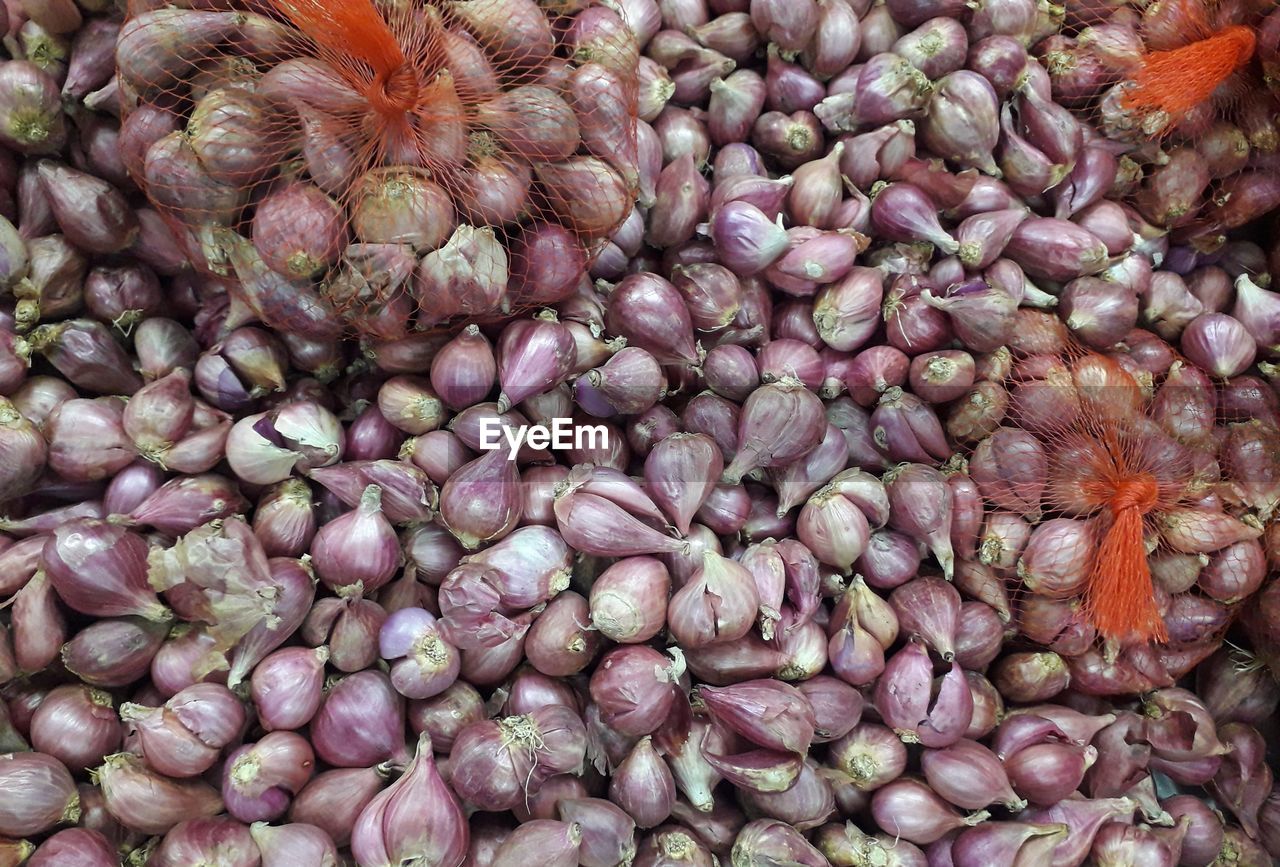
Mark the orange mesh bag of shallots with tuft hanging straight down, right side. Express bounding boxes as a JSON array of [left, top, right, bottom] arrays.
[[957, 316, 1264, 657]]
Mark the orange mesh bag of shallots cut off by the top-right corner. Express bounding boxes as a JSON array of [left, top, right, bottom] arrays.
[[1036, 0, 1280, 255]]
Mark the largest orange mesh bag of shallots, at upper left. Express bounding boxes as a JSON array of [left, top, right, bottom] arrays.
[[116, 0, 639, 339]]
